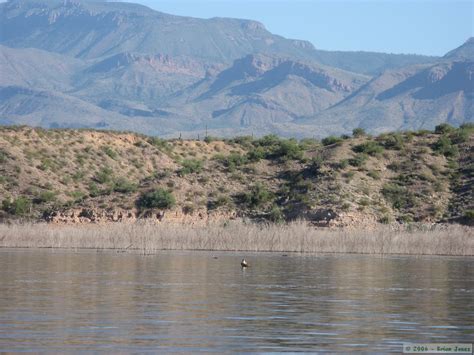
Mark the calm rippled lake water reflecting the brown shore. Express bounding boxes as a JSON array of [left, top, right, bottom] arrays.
[[0, 250, 474, 353]]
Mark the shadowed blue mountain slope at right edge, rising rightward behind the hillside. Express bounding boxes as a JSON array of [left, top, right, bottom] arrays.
[[305, 61, 474, 133]]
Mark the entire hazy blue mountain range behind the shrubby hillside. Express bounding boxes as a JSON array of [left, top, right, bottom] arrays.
[[0, 0, 474, 137]]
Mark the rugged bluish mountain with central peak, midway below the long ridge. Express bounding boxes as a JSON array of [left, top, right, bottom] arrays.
[[161, 55, 370, 135]]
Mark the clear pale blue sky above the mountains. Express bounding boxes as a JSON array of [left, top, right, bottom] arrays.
[[131, 0, 474, 55]]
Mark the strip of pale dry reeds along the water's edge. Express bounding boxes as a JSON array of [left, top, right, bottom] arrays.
[[0, 222, 474, 256]]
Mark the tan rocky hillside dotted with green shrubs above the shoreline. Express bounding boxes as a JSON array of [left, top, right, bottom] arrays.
[[0, 125, 474, 227]]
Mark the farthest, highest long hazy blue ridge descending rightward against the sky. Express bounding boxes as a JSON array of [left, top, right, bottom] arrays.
[[0, 0, 435, 74]]
